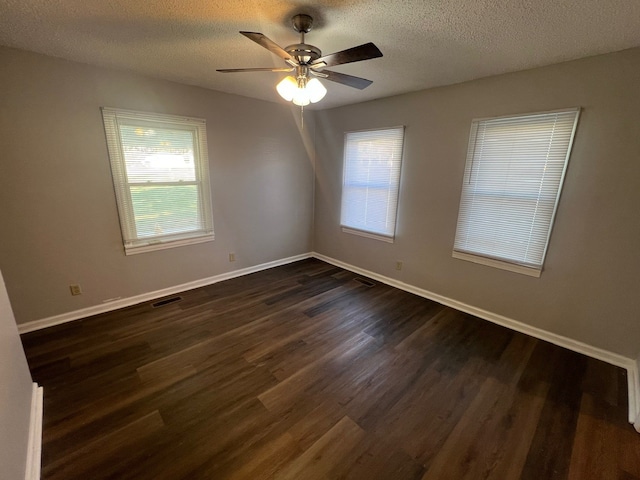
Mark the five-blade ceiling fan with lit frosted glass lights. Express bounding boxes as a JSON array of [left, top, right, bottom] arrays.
[[217, 14, 382, 106]]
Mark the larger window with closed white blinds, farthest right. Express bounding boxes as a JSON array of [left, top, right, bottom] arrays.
[[453, 108, 580, 277]]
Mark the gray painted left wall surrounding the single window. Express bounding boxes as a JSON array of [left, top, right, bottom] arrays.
[[0, 48, 313, 323]]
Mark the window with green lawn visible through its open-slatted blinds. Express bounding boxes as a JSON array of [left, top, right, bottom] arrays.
[[102, 108, 213, 255]]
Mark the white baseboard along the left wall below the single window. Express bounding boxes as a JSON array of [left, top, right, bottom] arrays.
[[18, 253, 311, 334]]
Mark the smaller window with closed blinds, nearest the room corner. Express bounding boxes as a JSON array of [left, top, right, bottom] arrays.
[[340, 127, 404, 243]]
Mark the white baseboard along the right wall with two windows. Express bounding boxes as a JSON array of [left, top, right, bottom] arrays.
[[311, 252, 640, 424]]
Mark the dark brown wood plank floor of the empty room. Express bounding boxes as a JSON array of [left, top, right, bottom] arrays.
[[23, 260, 640, 480]]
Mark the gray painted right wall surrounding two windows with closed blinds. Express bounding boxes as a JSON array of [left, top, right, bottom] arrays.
[[314, 49, 640, 358]]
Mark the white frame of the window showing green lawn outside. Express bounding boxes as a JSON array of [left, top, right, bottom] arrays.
[[101, 107, 215, 255]]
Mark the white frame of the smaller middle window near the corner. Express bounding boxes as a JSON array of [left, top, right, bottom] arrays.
[[340, 125, 406, 243]]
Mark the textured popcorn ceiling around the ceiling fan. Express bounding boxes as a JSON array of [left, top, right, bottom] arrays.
[[0, 0, 640, 108]]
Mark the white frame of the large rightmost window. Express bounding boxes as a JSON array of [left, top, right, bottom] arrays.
[[452, 107, 581, 277]]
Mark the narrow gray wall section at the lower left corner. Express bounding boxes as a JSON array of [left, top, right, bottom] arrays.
[[0, 272, 33, 480]]
